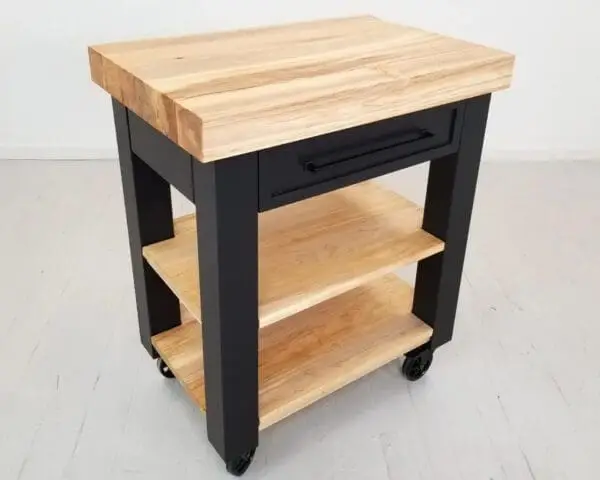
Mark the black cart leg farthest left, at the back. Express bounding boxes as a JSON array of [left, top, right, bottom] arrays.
[[113, 99, 181, 358]]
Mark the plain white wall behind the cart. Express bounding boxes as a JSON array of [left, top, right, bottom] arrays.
[[0, 0, 600, 159]]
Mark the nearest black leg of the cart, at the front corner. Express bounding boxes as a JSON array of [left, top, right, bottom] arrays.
[[193, 153, 259, 462]]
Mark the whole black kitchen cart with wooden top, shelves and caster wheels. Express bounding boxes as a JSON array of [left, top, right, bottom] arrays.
[[89, 17, 514, 475]]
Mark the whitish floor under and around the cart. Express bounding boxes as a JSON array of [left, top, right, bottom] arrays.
[[0, 161, 600, 480]]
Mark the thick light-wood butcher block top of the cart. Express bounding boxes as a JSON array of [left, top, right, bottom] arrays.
[[89, 16, 514, 162]]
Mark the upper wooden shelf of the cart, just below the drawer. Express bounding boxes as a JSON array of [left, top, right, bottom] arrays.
[[143, 182, 444, 327]]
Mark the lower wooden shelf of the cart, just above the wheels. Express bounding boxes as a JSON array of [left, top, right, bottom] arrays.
[[152, 274, 432, 429]]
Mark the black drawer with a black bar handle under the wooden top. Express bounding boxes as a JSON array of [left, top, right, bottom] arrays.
[[259, 104, 463, 211]]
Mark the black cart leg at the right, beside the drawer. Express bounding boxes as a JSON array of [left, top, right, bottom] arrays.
[[413, 95, 490, 349]]
